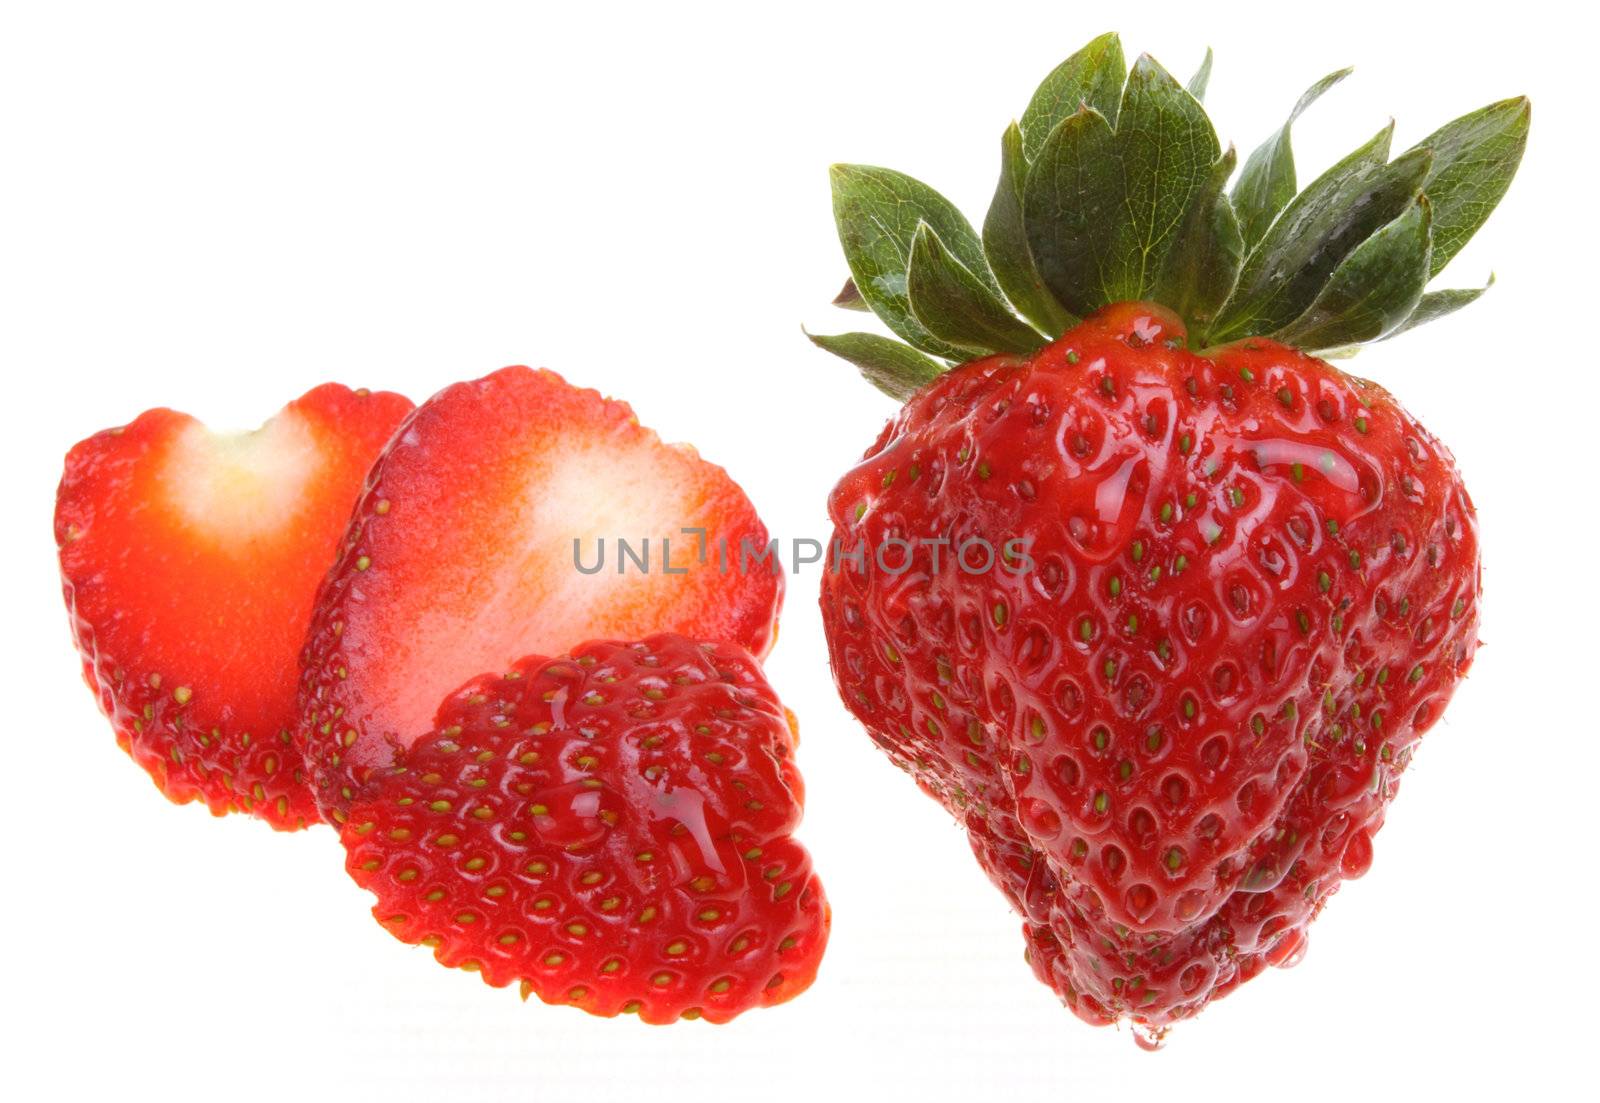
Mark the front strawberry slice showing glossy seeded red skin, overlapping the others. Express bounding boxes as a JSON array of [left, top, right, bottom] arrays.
[[334, 634, 829, 1023]]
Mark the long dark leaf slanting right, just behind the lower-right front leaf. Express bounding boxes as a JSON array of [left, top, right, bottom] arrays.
[[1208, 123, 1432, 343]]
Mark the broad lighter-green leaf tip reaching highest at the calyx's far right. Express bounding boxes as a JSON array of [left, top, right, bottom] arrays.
[[1414, 96, 1533, 275]]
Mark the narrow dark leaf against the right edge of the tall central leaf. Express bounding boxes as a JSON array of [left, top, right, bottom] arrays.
[[1154, 146, 1245, 335]]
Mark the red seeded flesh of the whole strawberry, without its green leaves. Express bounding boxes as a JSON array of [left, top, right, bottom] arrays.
[[822, 304, 1480, 1031]]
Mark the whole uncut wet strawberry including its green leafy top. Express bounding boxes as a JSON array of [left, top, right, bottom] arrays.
[[813, 35, 1528, 1044]]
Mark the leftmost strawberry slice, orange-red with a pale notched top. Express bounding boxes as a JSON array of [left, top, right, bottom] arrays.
[[54, 384, 411, 829]]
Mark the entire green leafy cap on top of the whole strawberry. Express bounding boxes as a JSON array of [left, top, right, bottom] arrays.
[[808, 34, 1530, 400]]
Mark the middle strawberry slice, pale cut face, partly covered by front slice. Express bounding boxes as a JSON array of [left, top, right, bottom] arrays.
[[301, 368, 782, 808]]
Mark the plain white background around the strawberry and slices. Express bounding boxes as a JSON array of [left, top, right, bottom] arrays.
[[0, 0, 1600, 1100]]
